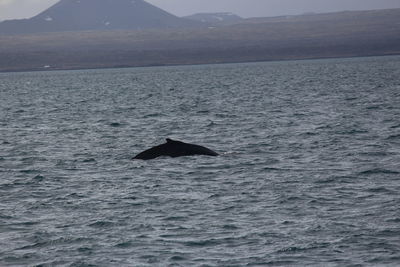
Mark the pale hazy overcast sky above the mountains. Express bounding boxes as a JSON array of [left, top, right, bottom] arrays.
[[0, 0, 400, 20]]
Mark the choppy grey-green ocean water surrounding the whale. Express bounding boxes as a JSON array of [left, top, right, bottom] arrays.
[[0, 57, 400, 266]]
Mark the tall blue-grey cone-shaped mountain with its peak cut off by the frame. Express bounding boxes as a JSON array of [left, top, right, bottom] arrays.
[[0, 0, 199, 35]]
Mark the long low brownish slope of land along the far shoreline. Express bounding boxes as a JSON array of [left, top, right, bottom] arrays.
[[0, 8, 400, 72]]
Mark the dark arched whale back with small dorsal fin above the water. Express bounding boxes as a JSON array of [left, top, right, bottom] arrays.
[[133, 139, 218, 160]]
